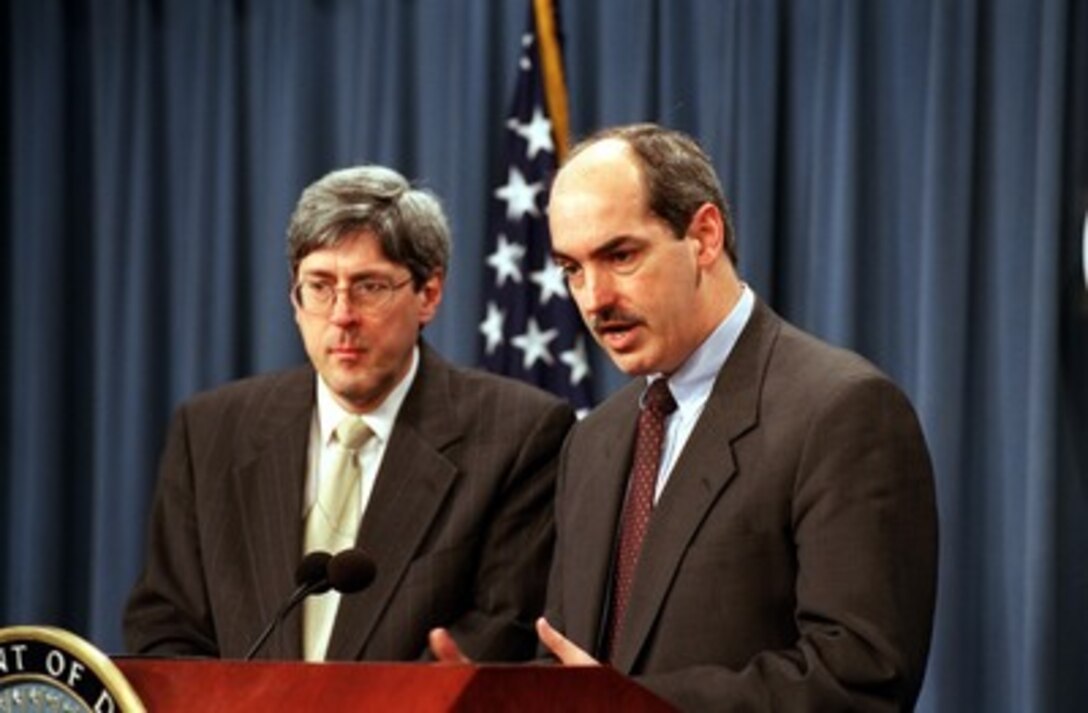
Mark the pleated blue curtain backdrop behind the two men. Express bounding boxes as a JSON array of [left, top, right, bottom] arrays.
[[0, 0, 1088, 711]]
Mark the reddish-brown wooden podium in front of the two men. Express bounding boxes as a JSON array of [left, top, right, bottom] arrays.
[[113, 657, 672, 713]]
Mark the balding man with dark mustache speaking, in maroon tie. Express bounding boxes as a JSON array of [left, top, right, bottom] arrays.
[[431, 124, 937, 711]]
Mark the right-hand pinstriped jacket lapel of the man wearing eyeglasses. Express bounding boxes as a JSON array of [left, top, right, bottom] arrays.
[[327, 346, 461, 660]]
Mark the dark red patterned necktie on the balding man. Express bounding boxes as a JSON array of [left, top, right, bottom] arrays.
[[604, 379, 677, 661]]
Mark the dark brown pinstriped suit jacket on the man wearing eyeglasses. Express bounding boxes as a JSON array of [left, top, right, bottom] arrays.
[[124, 346, 573, 661]]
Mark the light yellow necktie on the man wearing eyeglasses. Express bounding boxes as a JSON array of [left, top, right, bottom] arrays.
[[302, 416, 373, 661]]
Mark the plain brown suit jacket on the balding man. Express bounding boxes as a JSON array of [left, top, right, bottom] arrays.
[[547, 302, 937, 711]]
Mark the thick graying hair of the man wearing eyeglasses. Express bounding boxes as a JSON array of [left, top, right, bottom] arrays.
[[287, 165, 450, 290]]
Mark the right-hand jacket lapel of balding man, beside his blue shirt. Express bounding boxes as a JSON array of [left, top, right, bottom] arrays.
[[613, 302, 781, 674]]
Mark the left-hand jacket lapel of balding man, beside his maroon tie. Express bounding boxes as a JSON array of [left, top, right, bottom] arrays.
[[560, 379, 645, 652]]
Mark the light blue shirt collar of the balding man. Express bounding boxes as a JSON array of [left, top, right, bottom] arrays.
[[639, 285, 755, 417]]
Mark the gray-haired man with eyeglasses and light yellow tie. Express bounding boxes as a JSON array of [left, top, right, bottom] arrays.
[[124, 165, 573, 661]]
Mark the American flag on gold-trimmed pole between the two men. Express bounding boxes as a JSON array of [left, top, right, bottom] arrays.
[[480, 0, 593, 414]]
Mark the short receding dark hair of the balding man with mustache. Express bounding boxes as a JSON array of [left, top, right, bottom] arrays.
[[567, 123, 737, 266]]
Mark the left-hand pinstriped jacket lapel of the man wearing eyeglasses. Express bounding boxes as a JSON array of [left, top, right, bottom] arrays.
[[224, 368, 316, 659]]
